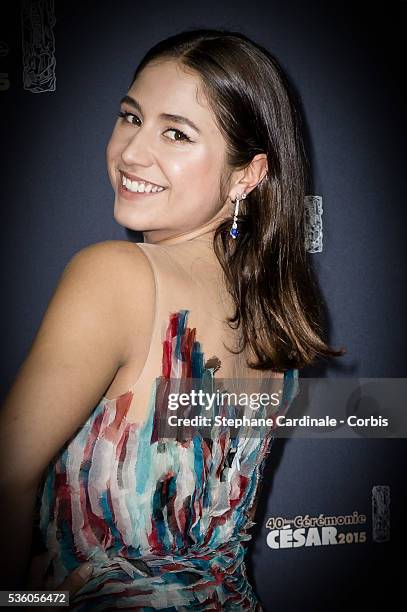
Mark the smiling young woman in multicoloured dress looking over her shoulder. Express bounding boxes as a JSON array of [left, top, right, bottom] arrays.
[[0, 30, 344, 610]]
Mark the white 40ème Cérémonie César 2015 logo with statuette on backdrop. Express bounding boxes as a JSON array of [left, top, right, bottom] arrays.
[[266, 485, 390, 550]]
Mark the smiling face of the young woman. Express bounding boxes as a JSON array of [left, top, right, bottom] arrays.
[[107, 60, 233, 242]]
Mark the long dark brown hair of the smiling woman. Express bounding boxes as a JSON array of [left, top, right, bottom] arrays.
[[131, 29, 346, 371]]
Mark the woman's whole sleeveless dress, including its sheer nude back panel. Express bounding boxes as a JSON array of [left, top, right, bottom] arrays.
[[39, 235, 298, 612]]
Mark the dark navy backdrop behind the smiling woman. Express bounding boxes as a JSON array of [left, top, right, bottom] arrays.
[[0, 0, 406, 612]]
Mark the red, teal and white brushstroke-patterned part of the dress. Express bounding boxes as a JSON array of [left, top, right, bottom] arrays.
[[40, 310, 298, 612]]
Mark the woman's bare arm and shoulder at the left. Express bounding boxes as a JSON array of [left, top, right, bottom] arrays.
[[0, 241, 150, 588]]
